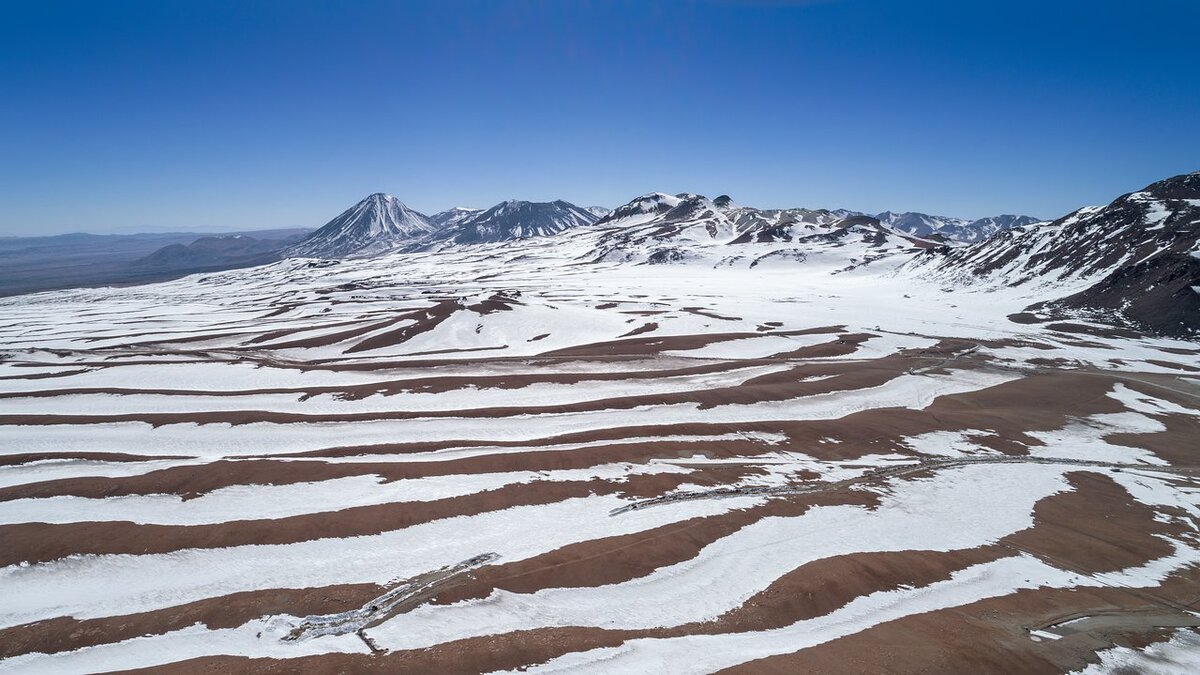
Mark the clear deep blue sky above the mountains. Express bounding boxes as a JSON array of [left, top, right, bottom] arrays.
[[0, 0, 1200, 234]]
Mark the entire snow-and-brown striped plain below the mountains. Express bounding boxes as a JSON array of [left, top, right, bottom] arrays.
[[0, 232, 1200, 673]]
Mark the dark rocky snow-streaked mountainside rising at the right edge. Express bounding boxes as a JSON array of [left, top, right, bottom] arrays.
[[907, 172, 1200, 335]]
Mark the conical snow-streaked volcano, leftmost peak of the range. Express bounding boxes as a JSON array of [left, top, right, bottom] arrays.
[[284, 192, 438, 258]]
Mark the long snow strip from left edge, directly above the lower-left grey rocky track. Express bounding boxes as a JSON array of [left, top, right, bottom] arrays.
[[0, 487, 762, 628]]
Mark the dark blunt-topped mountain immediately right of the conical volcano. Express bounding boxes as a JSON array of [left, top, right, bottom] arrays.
[[421, 199, 598, 246]]
